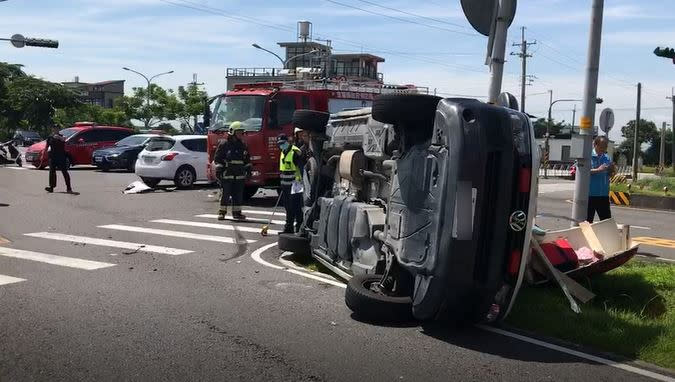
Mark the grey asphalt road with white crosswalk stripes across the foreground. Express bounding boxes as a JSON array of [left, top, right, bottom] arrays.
[[0, 168, 672, 381]]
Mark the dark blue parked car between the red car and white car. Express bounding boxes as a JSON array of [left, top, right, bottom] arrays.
[[91, 134, 161, 172]]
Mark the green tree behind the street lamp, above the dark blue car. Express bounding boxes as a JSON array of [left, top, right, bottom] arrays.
[[115, 84, 181, 128]]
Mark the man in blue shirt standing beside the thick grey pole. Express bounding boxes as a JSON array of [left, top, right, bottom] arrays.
[[586, 136, 615, 223]]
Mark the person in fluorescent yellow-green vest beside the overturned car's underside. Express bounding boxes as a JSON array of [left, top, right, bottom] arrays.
[[277, 134, 303, 233]]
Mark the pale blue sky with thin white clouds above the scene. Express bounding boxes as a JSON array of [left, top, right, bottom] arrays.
[[0, 0, 675, 140]]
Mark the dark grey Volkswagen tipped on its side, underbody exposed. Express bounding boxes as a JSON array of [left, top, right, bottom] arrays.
[[279, 94, 538, 322]]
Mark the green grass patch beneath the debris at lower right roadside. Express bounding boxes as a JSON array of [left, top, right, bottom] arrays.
[[507, 260, 675, 369]]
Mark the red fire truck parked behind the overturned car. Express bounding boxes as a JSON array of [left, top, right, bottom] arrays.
[[204, 81, 424, 198]]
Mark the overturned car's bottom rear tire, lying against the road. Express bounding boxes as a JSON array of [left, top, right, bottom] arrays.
[[345, 274, 412, 322]]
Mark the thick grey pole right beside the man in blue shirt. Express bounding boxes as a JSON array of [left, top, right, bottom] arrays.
[[572, 0, 605, 225]]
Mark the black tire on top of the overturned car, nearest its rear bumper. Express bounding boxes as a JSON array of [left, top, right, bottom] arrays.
[[372, 94, 441, 129]]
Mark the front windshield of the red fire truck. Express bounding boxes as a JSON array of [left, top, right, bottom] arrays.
[[209, 95, 266, 131]]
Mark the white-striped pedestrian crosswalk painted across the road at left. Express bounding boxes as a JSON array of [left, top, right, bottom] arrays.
[[0, 209, 285, 286]]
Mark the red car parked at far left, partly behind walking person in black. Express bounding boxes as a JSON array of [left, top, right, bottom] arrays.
[[24, 122, 134, 169]]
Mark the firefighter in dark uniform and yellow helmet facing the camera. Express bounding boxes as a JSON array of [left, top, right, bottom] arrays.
[[213, 121, 251, 220]]
